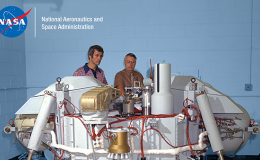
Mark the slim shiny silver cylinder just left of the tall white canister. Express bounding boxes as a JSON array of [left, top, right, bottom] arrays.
[[142, 85, 152, 115]]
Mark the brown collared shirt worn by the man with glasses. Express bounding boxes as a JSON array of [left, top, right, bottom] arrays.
[[114, 69, 144, 88]]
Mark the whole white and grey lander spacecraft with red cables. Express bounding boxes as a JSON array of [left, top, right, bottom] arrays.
[[4, 63, 259, 160]]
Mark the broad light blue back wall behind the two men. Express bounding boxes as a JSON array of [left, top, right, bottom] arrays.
[[0, 0, 260, 158]]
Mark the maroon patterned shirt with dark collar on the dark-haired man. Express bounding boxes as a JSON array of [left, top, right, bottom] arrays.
[[73, 63, 108, 85]]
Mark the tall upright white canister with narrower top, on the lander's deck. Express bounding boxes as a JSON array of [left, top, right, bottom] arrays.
[[151, 63, 174, 114]]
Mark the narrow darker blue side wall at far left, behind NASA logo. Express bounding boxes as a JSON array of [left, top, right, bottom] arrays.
[[0, 0, 27, 160]]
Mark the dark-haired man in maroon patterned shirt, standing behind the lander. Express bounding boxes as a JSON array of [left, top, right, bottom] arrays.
[[73, 45, 107, 85]]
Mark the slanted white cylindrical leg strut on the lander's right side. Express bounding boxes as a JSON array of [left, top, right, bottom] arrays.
[[196, 93, 224, 152]]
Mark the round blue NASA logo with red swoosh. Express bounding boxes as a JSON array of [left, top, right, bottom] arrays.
[[0, 6, 32, 38]]
